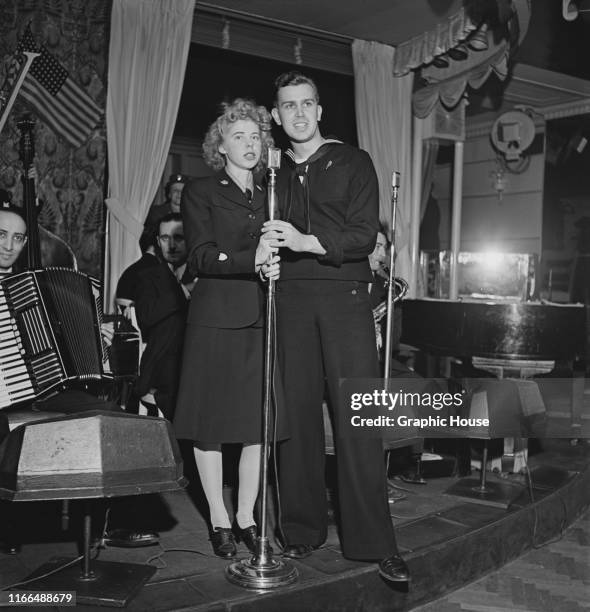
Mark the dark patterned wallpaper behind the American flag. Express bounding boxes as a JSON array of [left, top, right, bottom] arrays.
[[0, 0, 111, 278]]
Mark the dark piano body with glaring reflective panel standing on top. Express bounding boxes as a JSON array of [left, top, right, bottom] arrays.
[[402, 251, 587, 362]]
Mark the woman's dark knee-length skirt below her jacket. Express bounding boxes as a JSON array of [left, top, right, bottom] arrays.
[[174, 325, 280, 444]]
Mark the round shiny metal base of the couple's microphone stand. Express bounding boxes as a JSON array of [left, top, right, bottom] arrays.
[[225, 547, 297, 591]]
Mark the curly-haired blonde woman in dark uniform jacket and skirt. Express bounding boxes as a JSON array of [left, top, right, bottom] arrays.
[[174, 98, 279, 557]]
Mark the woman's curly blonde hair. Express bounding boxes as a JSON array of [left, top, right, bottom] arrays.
[[203, 98, 274, 172]]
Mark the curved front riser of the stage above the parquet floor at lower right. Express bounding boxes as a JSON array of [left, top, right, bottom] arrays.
[[224, 470, 590, 612]]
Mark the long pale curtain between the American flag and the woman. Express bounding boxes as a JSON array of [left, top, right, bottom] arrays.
[[104, 0, 195, 311]]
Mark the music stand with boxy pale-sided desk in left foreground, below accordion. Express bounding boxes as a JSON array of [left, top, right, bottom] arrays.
[[0, 410, 186, 607]]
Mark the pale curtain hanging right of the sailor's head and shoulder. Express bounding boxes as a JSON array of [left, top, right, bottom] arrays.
[[352, 40, 414, 279]]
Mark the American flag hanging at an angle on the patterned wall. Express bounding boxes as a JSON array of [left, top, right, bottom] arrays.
[[17, 25, 102, 148]]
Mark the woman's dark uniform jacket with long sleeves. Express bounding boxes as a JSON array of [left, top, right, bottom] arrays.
[[181, 171, 266, 328]]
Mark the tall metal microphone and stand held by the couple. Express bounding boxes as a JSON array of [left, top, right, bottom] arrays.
[[226, 147, 297, 591]]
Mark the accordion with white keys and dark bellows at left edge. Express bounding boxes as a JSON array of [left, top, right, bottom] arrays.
[[0, 268, 112, 409]]
